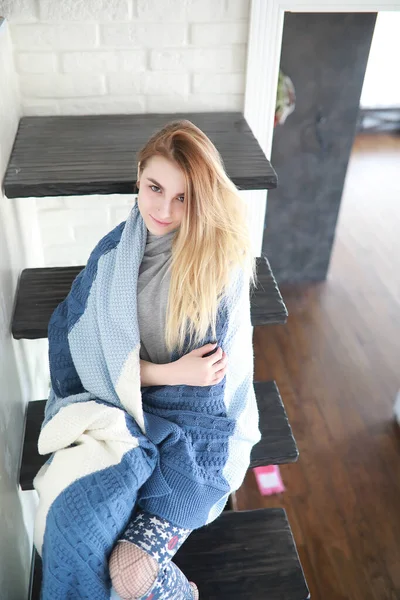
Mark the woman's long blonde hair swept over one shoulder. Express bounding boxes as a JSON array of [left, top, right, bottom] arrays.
[[137, 120, 256, 352]]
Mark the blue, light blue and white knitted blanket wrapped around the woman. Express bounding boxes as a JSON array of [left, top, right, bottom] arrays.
[[34, 203, 261, 600]]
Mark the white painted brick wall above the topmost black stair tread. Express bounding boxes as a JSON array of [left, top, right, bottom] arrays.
[[0, 0, 250, 115]]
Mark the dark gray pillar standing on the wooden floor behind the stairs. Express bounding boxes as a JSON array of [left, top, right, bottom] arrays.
[[262, 13, 376, 282]]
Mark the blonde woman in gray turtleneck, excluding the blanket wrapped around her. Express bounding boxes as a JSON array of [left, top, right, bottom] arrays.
[[110, 121, 260, 599]]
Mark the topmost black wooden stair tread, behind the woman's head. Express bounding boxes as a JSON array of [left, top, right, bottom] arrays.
[[3, 112, 277, 198]]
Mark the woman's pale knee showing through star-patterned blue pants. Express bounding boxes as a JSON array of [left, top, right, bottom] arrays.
[[109, 542, 159, 600]]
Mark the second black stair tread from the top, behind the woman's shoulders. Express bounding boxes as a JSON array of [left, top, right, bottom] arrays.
[[12, 256, 288, 340]]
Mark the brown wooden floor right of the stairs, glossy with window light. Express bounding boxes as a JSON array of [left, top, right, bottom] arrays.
[[237, 134, 400, 600]]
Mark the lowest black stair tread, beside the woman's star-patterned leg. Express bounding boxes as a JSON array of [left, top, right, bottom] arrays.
[[29, 508, 310, 600]]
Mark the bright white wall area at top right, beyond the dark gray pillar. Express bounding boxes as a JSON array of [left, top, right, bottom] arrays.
[[360, 12, 400, 108]]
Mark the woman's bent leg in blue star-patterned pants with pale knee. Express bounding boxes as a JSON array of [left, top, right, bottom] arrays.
[[109, 509, 198, 600]]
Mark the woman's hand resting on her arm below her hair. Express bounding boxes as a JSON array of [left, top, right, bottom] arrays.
[[169, 344, 228, 386]]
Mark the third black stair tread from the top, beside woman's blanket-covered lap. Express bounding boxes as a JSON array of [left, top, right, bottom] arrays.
[[19, 381, 298, 490]]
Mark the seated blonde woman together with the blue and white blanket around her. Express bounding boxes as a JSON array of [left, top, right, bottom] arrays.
[[34, 120, 260, 600]]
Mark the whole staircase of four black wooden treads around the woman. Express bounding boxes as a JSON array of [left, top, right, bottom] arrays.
[[3, 113, 310, 600]]
